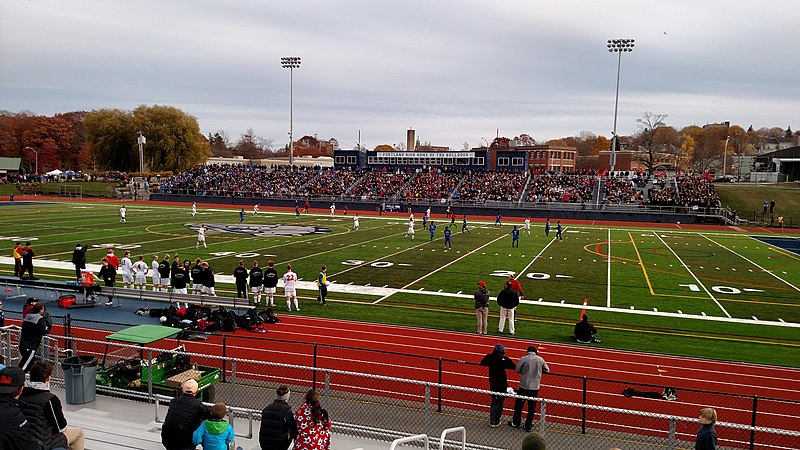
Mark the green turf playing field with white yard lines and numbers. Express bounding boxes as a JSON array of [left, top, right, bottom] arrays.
[[0, 202, 800, 367]]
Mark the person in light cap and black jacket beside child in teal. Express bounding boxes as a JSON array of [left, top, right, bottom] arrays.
[[161, 379, 211, 450]]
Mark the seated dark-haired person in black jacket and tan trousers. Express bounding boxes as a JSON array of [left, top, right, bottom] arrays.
[[19, 361, 85, 450]]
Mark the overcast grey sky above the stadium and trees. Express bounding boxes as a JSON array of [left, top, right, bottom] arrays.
[[0, 0, 800, 150]]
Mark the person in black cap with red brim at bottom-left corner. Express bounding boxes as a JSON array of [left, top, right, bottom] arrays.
[[0, 367, 46, 450]]
